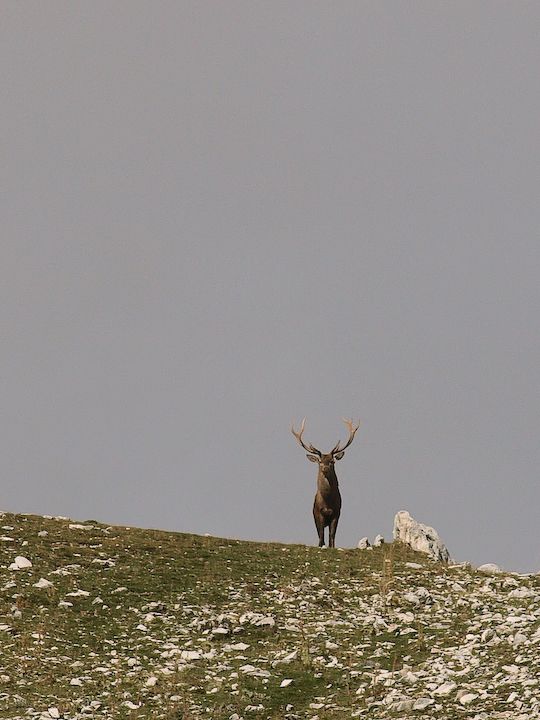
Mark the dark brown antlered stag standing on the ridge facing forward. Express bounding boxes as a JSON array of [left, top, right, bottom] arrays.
[[291, 418, 360, 548]]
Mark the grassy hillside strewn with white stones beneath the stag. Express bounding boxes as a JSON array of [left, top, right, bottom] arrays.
[[0, 513, 540, 720]]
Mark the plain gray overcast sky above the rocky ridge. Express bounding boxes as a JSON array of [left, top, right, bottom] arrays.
[[0, 0, 540, 570]]
